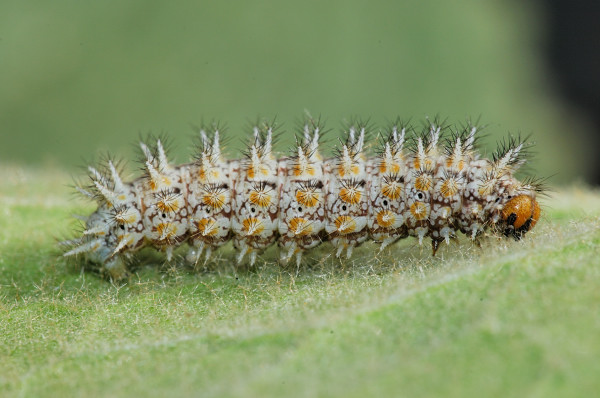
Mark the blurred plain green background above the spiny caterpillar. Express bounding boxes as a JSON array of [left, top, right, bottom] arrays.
[[0, 0, 593, 183]]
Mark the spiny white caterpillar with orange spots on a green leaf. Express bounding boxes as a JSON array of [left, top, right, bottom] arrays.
[[61, 117, 543, 279]]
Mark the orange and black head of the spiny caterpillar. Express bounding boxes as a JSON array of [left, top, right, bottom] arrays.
[[501, 195, 540, 240]]
